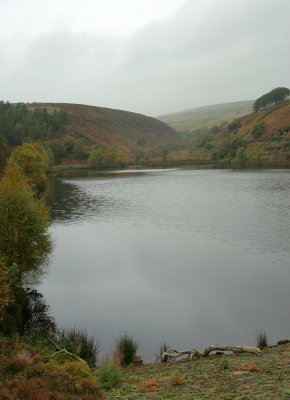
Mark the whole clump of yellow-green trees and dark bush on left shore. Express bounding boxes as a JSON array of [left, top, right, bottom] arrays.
[[0, 145, 54, 335]]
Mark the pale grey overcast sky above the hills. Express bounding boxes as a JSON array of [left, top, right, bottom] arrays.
[[0, 0, 290, 116]]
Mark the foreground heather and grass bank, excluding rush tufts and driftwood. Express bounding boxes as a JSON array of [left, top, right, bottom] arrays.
[[0, 338, 290, 400]]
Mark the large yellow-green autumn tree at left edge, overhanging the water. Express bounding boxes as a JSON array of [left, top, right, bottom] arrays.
[[0, 160, 52, 282]]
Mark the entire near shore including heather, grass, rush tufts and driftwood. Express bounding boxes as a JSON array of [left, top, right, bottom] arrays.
[[0, 329, 290, 400]]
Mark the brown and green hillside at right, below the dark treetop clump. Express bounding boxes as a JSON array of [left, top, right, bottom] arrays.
[[192, 101, 290, 166]]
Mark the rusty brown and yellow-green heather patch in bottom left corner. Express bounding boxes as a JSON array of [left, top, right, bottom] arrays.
[[0, 338, 103, 400]]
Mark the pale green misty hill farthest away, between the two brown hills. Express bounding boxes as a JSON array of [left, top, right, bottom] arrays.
[[158, 100, 254, 132]]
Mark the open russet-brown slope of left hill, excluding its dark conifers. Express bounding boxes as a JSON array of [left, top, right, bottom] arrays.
[[30, 103, 187, 157]]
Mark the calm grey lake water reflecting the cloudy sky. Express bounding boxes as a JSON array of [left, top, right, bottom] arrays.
[[41, 169, 290, 360]]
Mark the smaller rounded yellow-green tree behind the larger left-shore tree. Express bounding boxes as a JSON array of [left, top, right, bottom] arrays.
[[11, 143, 49, 196]]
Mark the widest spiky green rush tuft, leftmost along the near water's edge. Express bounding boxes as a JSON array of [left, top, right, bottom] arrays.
[[57, 328, 100, 368]]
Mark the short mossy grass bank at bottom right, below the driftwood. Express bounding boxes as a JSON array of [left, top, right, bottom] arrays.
[[105, 344, 290, 400]]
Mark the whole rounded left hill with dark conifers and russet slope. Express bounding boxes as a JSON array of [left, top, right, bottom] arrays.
[[0, 102, 188, 166]]
